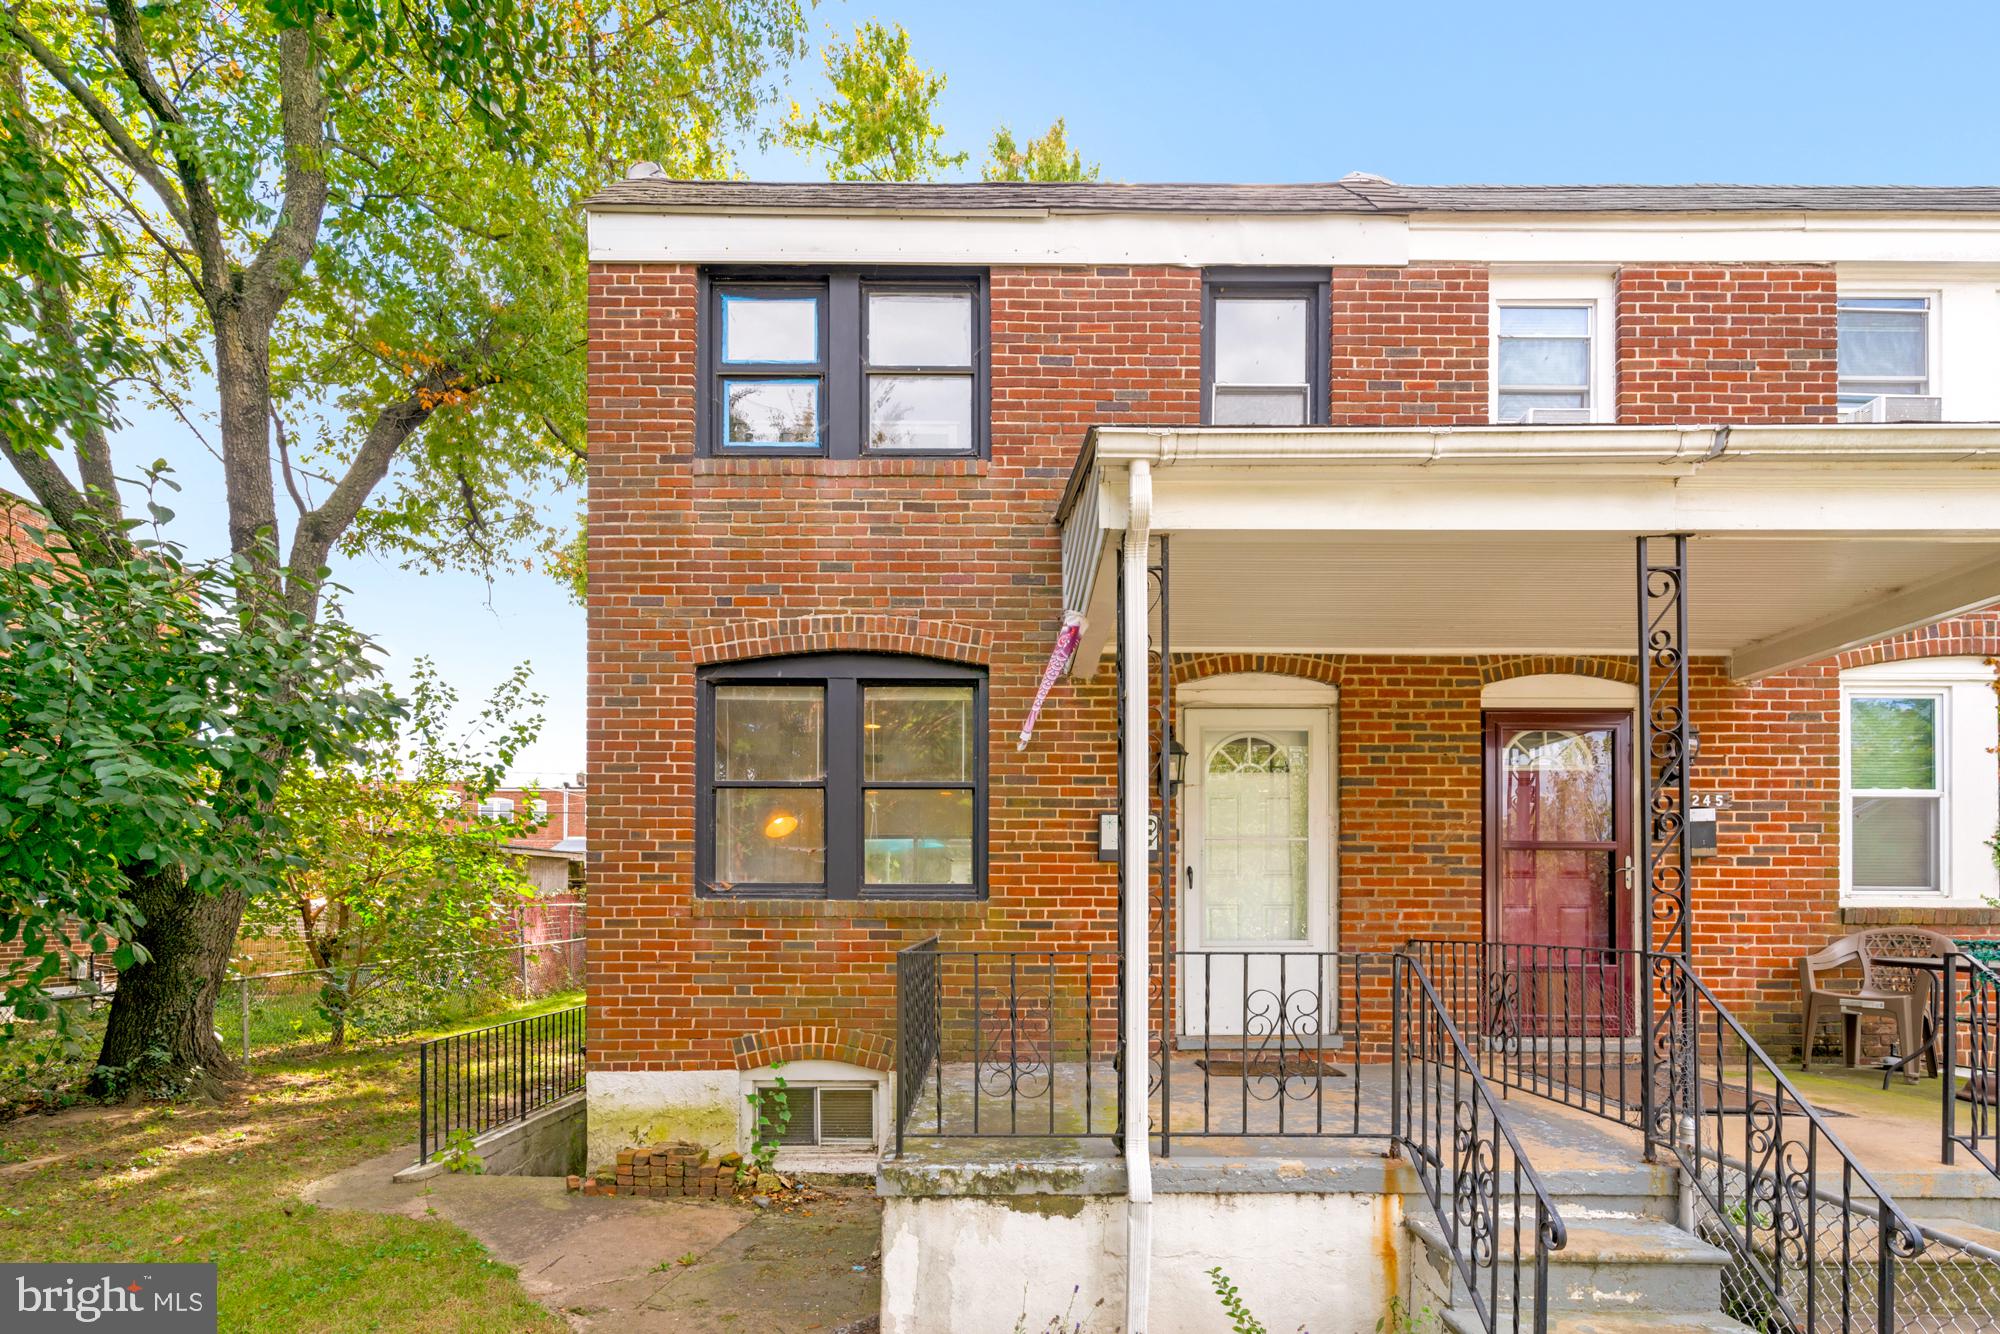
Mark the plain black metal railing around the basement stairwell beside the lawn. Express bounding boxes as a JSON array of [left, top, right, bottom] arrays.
[[416, 1006, 586, 1162]]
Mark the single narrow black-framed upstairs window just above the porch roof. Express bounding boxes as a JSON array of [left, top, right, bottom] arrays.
[[1202, 270, 1330, 426]]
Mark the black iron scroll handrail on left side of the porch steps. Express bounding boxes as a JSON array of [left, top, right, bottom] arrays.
[[1392, 954, 1570, 1332]]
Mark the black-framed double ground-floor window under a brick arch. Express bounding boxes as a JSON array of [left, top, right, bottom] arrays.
[[696, 654, 986, 898]]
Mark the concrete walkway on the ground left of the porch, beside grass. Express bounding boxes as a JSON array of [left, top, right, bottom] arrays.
[[306, 1152, 882, 1334]]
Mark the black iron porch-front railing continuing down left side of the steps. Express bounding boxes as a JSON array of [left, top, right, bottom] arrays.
[[896, 940, 1568, 1332]]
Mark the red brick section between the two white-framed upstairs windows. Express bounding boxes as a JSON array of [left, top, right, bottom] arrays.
[[1618, 266, 1838, 424]]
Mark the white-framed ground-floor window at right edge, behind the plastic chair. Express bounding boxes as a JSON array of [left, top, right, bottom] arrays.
[[1840, 658, 2000, 904]]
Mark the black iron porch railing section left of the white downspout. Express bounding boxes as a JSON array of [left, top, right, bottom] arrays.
[[896, 940, 1120, 1154]]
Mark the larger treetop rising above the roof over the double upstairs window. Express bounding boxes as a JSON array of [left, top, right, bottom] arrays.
[[780, 20, 966, 180]]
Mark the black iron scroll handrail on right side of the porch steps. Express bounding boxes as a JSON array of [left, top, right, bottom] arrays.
[[1646, 954, 1926, 1334]]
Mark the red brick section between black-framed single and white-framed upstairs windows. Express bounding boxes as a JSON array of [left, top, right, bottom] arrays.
[[1330, 264, 1492, 426]]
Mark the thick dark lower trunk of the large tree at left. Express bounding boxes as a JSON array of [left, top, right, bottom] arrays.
[[92, 872, 244, 1096]]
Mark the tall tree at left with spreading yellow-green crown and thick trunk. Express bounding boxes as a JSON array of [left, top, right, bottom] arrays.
[[0, 0, 804, 1088]]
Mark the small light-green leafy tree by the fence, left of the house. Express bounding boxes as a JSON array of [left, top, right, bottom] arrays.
[[246, 658, 542, 1046]]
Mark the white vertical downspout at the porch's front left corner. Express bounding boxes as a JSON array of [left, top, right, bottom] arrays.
[[1118, 458, 1152, 1334]]
